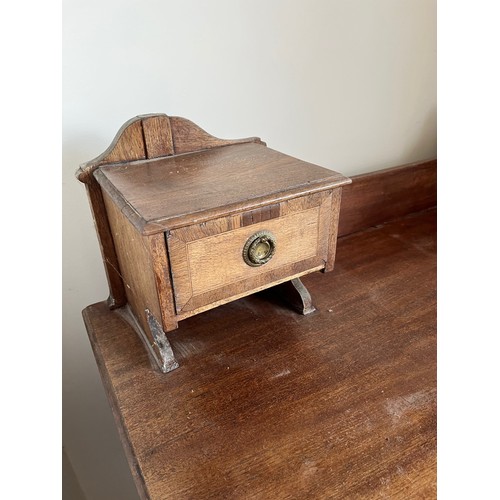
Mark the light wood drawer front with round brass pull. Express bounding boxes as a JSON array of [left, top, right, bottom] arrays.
[[167, 191, 332, 317]]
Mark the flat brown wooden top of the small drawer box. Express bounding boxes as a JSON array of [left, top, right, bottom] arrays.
[[94, 143, 351, 234]]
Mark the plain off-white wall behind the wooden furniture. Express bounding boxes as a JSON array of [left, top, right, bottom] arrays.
[[63, 0, 436, 500]]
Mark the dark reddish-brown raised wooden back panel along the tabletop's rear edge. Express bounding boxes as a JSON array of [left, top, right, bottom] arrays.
[[339, 160, 437, 236]]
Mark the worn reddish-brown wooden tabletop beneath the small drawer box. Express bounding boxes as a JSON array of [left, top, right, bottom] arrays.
[[84, 209, 436, 500]]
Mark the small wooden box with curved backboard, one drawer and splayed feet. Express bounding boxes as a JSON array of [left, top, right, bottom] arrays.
[[77, 115, 350, 372]]
